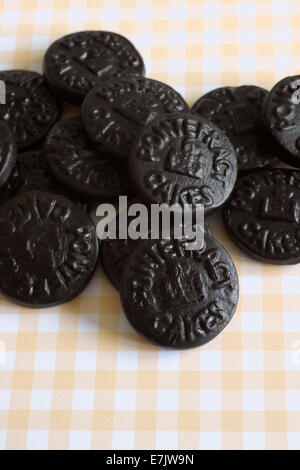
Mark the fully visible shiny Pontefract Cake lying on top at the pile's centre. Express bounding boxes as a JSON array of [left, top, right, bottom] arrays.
[[129, 113, 237, 215]]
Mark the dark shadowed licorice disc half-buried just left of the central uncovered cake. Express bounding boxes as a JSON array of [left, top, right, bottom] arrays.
[[44, 117, 128, 199]]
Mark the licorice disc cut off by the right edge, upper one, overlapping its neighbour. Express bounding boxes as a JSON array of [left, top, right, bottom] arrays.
[[263, 75, 300, 168]]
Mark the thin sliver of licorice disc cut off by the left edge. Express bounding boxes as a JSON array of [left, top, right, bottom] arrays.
[[0, 119, 17, 187]]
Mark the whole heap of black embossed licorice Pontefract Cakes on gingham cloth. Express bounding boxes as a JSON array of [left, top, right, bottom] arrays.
[[0, 31, 300, 349]]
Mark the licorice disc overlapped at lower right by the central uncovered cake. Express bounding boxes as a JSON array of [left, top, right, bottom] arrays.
[[81, 77, 189, 161]]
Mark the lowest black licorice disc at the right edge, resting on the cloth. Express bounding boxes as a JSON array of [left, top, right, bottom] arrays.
[[224, 168, 300, 264]]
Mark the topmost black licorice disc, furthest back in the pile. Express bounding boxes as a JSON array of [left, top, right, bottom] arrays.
[[43, 31, 145, 104]]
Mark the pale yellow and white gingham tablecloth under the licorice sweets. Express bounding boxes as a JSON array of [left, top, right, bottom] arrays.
[[0, 0, 300, 449]]
